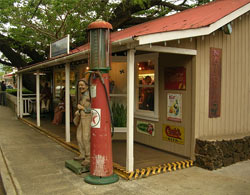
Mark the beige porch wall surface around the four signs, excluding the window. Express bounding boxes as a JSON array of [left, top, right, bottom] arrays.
[[134, 52, 195, 157]]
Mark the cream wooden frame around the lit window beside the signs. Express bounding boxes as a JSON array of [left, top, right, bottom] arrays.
[[134, 53, 159, 121]]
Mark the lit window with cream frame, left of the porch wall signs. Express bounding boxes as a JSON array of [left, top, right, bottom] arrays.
[[135, 54, 158, 120]]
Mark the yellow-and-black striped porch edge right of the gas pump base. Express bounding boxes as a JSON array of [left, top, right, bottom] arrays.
[[114, 160, 194, 180]]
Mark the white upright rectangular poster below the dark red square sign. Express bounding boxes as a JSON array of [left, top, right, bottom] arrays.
[[167, 93, 182, 122]]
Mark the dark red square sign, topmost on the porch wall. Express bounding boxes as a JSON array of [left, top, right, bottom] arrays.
[[164, 67, 186, 90]]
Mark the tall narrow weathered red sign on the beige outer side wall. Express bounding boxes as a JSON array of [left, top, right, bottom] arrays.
[[209, 48, 222, 118]]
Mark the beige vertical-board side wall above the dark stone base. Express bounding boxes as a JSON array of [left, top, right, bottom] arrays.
[[193, 13, 250, 139]]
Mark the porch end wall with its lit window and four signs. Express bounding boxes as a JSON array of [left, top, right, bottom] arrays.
[[135, 53, 192, 158]]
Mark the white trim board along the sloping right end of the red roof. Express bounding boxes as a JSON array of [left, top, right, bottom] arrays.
[[135, 3, 250, 45]]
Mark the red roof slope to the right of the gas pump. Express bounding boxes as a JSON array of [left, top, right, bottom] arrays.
[[111, 0, 250, 41]]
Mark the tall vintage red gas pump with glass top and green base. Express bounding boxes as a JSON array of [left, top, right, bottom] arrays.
[[84, 20, 119, 184]]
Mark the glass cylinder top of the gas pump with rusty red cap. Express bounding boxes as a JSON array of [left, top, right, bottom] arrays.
[[88, 20, 112, 70]]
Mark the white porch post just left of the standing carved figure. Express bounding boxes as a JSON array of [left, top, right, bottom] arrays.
[[65, 63, 70, 142]]
